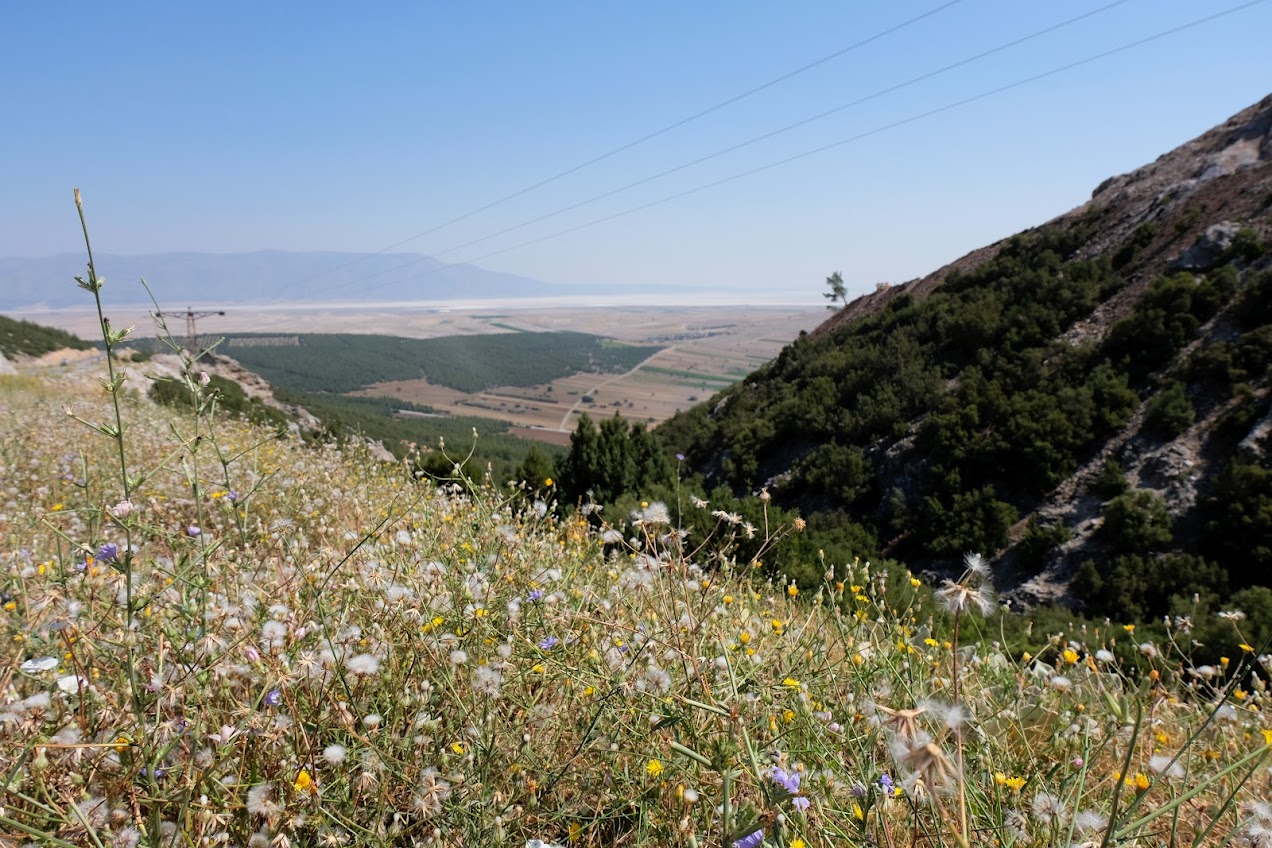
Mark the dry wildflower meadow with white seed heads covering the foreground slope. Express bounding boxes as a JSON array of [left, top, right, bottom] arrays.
[[7, 194, 1272, 848]]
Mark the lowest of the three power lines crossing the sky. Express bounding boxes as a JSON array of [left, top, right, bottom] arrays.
[[358, 0, 1267, 285]]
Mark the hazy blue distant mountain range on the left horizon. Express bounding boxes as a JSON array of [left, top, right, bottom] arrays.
[[0, 250, 577, 309]]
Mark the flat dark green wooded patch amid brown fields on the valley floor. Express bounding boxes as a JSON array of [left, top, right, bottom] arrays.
[[221, 332, 659, 394]]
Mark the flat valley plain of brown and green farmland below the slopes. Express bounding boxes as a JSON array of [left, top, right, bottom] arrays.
[[22, 298, 827, 444]]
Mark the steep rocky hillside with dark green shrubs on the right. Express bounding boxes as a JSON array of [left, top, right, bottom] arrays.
[[660, 97, 1272, 617]]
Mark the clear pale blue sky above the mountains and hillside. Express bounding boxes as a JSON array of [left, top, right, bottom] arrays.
[[0, 0, 1272, 299]]
